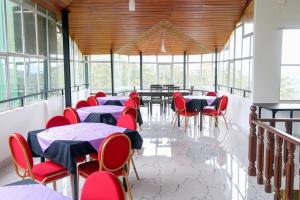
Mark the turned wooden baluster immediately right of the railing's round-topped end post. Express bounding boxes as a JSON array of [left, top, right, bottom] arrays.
[[257, 127, 265, 185]]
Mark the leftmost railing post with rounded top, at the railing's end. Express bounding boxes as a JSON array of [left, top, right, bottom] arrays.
[[248, 105, 257, 176]]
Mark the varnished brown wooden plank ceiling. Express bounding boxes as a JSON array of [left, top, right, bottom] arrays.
[[34, 0, 252, 55]]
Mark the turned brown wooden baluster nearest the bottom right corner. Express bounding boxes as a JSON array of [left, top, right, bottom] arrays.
[[285, 142, 295, 200]]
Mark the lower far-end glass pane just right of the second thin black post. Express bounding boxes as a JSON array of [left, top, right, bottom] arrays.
[[143, 64, 158, 89]]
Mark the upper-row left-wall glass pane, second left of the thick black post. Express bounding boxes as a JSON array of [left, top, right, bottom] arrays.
[[37, 15, 47, 55]]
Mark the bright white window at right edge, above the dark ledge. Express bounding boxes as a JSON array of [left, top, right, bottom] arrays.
[[280, 29, 300, 100]]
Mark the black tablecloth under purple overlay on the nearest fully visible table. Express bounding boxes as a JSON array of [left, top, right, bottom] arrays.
[[27, 129, 143, 173]]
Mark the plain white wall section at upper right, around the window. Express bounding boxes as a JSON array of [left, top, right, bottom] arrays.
[[253, 0, 300, 103]]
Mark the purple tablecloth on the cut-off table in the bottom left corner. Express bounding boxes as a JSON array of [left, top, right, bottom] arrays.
[[0, 184, 70, 200]]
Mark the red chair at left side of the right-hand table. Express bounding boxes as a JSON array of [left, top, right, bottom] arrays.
[[173, 95, 199, 131]]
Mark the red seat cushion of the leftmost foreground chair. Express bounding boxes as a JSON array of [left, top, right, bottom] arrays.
[[31, 161, 69, 183]]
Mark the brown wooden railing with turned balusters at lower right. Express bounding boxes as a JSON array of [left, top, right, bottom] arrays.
[[248, 106, 300, 200]]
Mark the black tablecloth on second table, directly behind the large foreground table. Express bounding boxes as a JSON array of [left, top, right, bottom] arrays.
[[84, 109, 143, 125]]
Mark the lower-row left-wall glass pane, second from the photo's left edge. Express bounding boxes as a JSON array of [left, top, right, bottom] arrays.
[[9, 57, 25, 108]]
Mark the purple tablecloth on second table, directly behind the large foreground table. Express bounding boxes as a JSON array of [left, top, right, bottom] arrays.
[[77, 105, 125, 122]]
